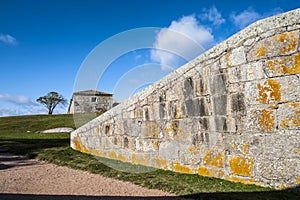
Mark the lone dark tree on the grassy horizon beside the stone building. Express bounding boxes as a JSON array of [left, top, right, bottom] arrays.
[[36, 92, 67, 115]]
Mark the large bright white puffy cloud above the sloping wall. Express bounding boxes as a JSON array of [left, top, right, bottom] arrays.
[[151, 16, 214, 70]]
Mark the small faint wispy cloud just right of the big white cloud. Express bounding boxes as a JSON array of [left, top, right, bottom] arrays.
[[199, 6, 226, 26]]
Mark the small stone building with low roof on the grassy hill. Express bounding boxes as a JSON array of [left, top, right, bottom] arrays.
[[68, 90, 115, 114]]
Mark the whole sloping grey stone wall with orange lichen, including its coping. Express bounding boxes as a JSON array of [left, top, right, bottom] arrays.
[[71, 9, 300, 188]]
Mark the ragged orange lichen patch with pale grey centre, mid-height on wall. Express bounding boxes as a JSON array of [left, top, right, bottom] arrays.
[[256, 79, 281, 104]]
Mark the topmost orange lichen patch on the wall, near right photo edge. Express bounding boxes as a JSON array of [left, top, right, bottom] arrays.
[[272, 31, 299, 54]]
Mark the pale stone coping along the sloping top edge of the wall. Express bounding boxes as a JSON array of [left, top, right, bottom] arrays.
[[75, 8, 300, 132]]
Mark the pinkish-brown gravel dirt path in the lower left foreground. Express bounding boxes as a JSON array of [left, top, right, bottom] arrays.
[[0, 152, 184, 200]]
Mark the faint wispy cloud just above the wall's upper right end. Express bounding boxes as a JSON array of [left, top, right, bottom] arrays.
[[230, 7, 283, 29]]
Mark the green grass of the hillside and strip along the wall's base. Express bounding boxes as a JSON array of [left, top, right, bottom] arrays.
[[0, 114, 300, 200]]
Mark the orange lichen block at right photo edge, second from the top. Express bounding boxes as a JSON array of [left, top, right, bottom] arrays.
[[267, 53, 300, 75]]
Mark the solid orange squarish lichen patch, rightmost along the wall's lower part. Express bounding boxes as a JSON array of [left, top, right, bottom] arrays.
[[229, 156, 254, 176]]
